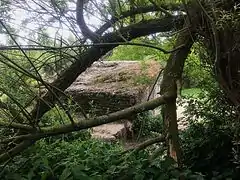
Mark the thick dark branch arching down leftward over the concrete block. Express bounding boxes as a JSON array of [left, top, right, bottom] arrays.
[[29, 16, 184, 124]]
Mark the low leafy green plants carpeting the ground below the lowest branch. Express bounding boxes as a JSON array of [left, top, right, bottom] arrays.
[[0, 136, 204, 180]]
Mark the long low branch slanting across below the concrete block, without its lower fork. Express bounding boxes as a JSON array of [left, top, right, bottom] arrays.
[[0, 94, 173, 143]]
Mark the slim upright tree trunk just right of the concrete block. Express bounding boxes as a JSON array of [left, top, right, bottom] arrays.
[[160, 26, 193, 167]]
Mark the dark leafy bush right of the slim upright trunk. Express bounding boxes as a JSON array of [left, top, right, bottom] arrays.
[[181, 86, 240, 179]]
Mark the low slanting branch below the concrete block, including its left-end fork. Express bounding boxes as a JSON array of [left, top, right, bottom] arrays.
[[0, 94, 173, 163]]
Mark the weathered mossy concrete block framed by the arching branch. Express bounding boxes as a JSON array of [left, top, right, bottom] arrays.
[[66, 61, 161, 115]]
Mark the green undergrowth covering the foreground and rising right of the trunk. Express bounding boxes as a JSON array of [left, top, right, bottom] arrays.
[[0, 82, 240, 180]]
